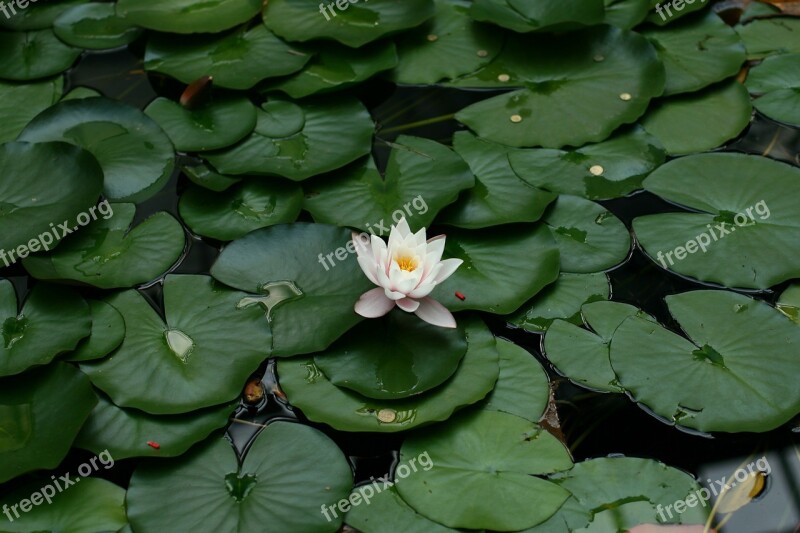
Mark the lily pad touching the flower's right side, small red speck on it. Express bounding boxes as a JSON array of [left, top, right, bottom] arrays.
[[431, 224, 559, 315]]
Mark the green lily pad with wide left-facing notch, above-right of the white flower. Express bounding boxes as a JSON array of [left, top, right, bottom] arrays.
[[437, 131, 556, 228]]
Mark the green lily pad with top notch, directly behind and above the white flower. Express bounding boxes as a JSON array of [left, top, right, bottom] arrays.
[[303, 135, 475, 235]]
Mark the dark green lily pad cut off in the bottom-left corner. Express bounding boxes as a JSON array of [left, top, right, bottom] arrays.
[[0, 476, 128, 533]]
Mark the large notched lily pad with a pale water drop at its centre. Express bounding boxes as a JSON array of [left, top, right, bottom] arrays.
[[81, 275, 271, 415]]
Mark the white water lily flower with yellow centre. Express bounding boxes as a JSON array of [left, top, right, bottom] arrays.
[[353, 217, 463, 328]]
